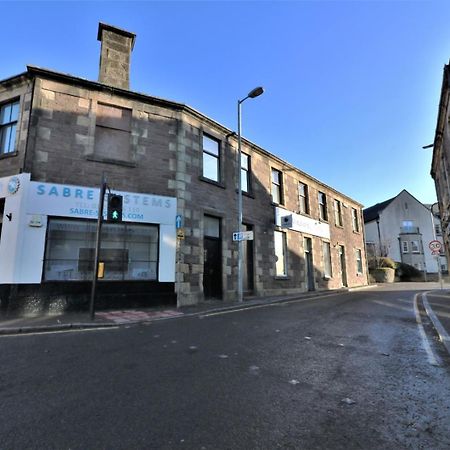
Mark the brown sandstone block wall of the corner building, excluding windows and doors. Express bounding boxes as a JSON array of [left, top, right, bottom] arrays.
[[0, 71, 367, 305]]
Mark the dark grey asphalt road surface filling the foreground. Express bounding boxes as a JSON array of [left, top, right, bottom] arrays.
[[0, 288, 450, 450]]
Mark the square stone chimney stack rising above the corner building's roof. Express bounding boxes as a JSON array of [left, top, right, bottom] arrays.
[[97, 22, 136, 89]]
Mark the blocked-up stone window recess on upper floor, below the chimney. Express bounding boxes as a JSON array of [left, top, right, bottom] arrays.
[[95, 103, 131, 162]]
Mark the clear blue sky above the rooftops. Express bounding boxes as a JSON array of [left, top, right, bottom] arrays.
[[0, 0, 450, 207]]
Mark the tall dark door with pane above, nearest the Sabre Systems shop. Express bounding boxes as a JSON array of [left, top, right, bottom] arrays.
[[203, 216, 222, 299]]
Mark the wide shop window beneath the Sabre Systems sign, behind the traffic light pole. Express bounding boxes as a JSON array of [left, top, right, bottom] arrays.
[[44, 218, 159, 281]]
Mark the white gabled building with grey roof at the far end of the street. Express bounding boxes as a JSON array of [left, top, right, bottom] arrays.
[[364, 190, 448, 273]]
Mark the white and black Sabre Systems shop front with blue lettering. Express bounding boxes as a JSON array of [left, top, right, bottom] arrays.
[[0, 174, 176, 310]]
